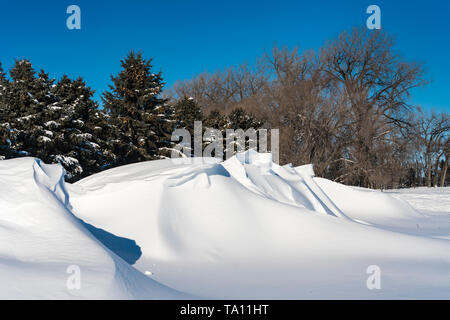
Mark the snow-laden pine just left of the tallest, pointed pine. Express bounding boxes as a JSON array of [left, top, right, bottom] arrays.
[[39, 76, 114, 182]]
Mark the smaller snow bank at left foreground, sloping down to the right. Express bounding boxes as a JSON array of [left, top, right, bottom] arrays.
[[0, 158, 183, 299]]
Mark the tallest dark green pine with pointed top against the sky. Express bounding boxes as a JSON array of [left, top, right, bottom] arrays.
[[102, 51, 174, 164]]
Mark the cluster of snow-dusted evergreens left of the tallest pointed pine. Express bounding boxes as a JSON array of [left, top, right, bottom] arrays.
[[0, 60, 115, 181]]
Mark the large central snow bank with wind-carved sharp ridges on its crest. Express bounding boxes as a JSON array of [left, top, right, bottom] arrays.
[[68, 152, 450, 299]]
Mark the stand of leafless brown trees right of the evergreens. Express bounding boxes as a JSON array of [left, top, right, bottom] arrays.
[[171, 29, 450, 188]]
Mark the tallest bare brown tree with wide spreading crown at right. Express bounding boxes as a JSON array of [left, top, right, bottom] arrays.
[[320, 29, 425, 187]]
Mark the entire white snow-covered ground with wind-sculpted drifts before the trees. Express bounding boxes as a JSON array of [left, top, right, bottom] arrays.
[[0, 152, 450, 299]]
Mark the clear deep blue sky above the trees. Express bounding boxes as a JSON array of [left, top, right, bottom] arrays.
[[0, 0, 450, 111]]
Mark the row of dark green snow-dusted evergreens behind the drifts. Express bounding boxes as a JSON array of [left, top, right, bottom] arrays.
[[0, 52, 260, 182]]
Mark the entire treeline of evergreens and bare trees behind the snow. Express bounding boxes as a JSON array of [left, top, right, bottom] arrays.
[[0, 30, 450, 188]]
